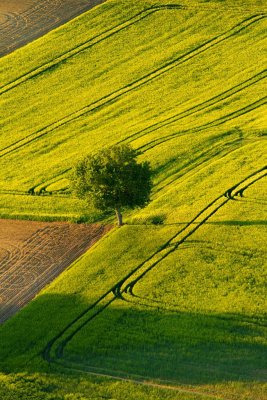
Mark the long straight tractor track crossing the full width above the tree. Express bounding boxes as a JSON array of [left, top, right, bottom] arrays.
[[0, 14, 266, 158]]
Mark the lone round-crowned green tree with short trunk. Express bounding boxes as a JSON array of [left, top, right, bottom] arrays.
[[71, 145, 152, 226]]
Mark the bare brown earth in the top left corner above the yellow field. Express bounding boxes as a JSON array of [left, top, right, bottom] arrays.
[[0, 0, 105, 56]]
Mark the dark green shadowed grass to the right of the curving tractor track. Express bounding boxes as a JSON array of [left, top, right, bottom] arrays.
[[62, 307, 267, 385]]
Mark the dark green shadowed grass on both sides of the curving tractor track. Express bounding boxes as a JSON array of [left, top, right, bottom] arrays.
[[0, 294, 267, 385]]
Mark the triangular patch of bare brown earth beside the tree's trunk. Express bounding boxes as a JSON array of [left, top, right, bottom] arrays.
[[0, 219, 110, 323]]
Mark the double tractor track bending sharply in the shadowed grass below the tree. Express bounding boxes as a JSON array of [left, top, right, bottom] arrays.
[[42, 166, 267, 399]]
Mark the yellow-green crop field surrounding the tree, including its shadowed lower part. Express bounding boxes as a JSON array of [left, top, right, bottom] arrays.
[[0, 0, 267, 400]]
